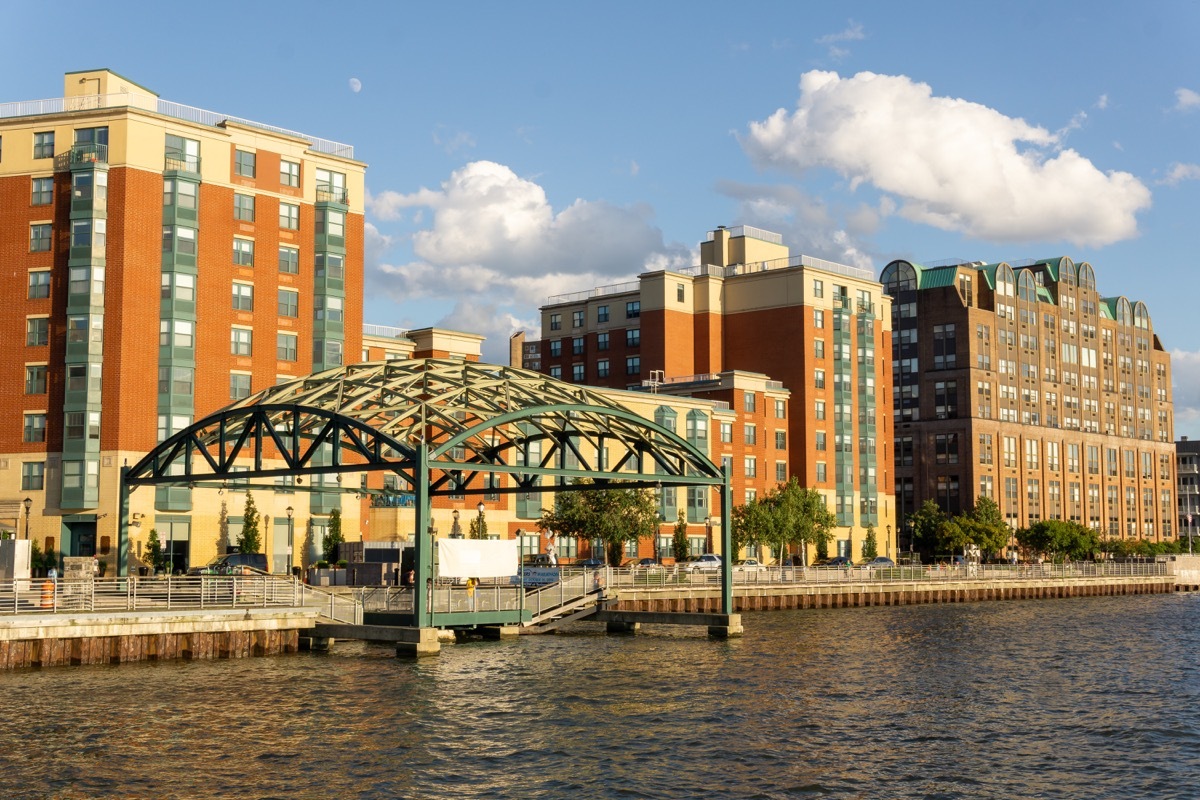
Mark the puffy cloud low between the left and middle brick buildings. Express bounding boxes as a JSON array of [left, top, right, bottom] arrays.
[[367, 161, 694, 337]]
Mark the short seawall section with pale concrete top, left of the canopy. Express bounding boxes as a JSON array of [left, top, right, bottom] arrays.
[[0, 608, 317, 669]]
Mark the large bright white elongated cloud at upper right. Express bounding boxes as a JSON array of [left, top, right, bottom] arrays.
[[742, 71, 1151, 247]]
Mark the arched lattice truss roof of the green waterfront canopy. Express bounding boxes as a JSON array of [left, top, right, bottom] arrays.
[[126, 359, 724, 495]]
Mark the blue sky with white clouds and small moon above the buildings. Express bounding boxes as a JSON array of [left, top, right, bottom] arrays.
[[0, 0, 1200, 439]]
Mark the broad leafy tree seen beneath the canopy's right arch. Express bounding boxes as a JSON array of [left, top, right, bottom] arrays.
[[538, 477, 659, 566]]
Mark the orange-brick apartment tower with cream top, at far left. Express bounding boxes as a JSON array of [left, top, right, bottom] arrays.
[[0, 70, 365, 567]]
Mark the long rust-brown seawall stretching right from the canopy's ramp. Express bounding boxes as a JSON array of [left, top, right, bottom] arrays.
[[607, 576, 1176, 613]]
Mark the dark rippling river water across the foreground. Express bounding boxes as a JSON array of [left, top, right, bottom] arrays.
[[0, 595, 1200, 800]]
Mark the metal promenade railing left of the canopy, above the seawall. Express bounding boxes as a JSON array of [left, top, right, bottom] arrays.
[[0, 575, 310, 614]]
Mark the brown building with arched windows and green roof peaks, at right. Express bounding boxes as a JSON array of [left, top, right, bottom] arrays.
[[881, 258, 1176, 547]]
